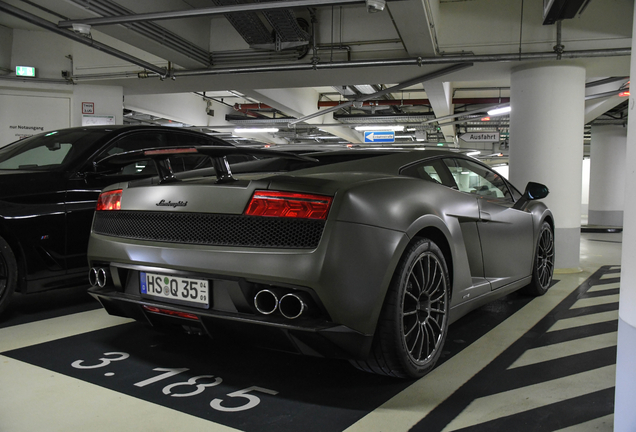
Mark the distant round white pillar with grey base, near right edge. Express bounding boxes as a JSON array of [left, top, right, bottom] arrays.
[[587, 126, 627, 227]]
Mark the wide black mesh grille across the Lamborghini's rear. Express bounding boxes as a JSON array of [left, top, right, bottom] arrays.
[[93, 211, 325, 248]]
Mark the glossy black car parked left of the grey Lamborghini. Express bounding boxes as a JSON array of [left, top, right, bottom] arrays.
[[0, 126, 230, 312]]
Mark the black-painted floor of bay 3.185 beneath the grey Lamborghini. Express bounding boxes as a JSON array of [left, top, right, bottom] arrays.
[[2, 286, 532, 432]]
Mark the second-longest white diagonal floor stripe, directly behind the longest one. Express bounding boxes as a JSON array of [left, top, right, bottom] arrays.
[[508, 332, 618, 369]]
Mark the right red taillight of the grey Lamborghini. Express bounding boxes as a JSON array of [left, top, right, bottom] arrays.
[[245, 191, 333, 219]]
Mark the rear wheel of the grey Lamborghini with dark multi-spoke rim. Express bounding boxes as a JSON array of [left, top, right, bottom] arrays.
[[354, 239, 451, 378]]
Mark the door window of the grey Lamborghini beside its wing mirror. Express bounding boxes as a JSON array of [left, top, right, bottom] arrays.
[[444, 158, 513, 201]]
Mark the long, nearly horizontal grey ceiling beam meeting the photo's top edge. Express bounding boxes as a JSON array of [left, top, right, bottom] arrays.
[[57, 0, 365, 28]]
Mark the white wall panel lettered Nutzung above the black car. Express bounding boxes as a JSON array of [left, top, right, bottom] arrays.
[[0, 94, 71, 147]]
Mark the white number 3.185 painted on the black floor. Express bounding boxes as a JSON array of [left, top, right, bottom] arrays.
[[71, 352, 278, 412]]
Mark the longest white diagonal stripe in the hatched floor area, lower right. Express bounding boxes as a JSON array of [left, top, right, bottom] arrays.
[[442, 365, 616, 432]]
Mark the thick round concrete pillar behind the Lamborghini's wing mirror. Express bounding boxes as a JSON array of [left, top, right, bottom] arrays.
[[510, 62, 585, 269]]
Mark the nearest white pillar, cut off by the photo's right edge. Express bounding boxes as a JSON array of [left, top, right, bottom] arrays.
[[614, 5, 636, 432]]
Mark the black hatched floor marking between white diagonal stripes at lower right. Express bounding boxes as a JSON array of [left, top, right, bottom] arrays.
[[411, 266, 620, 432]]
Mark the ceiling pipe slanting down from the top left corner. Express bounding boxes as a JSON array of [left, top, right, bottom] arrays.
[[0, 1, 168, 77]]
